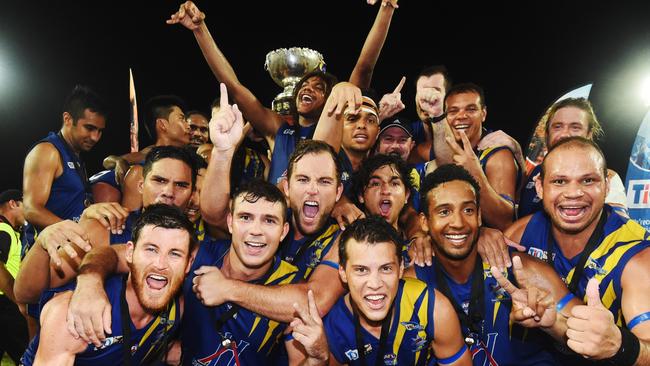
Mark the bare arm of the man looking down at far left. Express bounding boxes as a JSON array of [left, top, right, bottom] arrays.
[[23, 143, 63, 228]]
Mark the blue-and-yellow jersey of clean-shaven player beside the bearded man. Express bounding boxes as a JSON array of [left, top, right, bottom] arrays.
[[181, 240, 299, 366]]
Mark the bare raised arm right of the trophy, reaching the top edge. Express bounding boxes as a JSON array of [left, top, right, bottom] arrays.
[[350, 0, 397, 88]]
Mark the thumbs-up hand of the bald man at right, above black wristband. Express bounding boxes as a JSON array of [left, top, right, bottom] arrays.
[[566, 278, 621, 360]]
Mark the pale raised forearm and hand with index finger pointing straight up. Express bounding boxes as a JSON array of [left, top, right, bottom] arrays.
[[200, 83, 244, 230]]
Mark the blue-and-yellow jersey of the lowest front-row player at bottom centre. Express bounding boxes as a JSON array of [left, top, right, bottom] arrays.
[[323, 278, 435, 365]]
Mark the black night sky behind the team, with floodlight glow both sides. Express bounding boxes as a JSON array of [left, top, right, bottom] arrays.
[[0, 0, 650, 189]]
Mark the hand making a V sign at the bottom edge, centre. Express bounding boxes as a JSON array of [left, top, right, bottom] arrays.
[[290, 290, 329, 365]]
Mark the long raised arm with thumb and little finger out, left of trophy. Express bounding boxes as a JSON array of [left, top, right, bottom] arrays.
[[167, 1, 282, 141]]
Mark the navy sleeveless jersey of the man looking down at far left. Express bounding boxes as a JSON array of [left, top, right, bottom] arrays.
[[23, 132, 92, 254]]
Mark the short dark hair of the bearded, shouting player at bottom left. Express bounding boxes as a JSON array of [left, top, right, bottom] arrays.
[[132, 203, 198, 253]]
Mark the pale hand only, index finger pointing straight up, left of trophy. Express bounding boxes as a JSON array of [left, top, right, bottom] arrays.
[[210, 83, 244, 153]]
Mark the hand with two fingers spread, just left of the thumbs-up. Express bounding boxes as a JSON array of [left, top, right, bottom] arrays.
[[490, 256, 556, 328]]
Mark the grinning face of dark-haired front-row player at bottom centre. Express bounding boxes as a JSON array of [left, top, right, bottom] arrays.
[[339, 238, 404, 327]]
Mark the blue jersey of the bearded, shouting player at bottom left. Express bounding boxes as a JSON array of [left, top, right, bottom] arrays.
[[21, 276, 181, 366]]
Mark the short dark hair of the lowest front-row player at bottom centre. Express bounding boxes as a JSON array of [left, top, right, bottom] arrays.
[[339, 215, 404, 267]]
